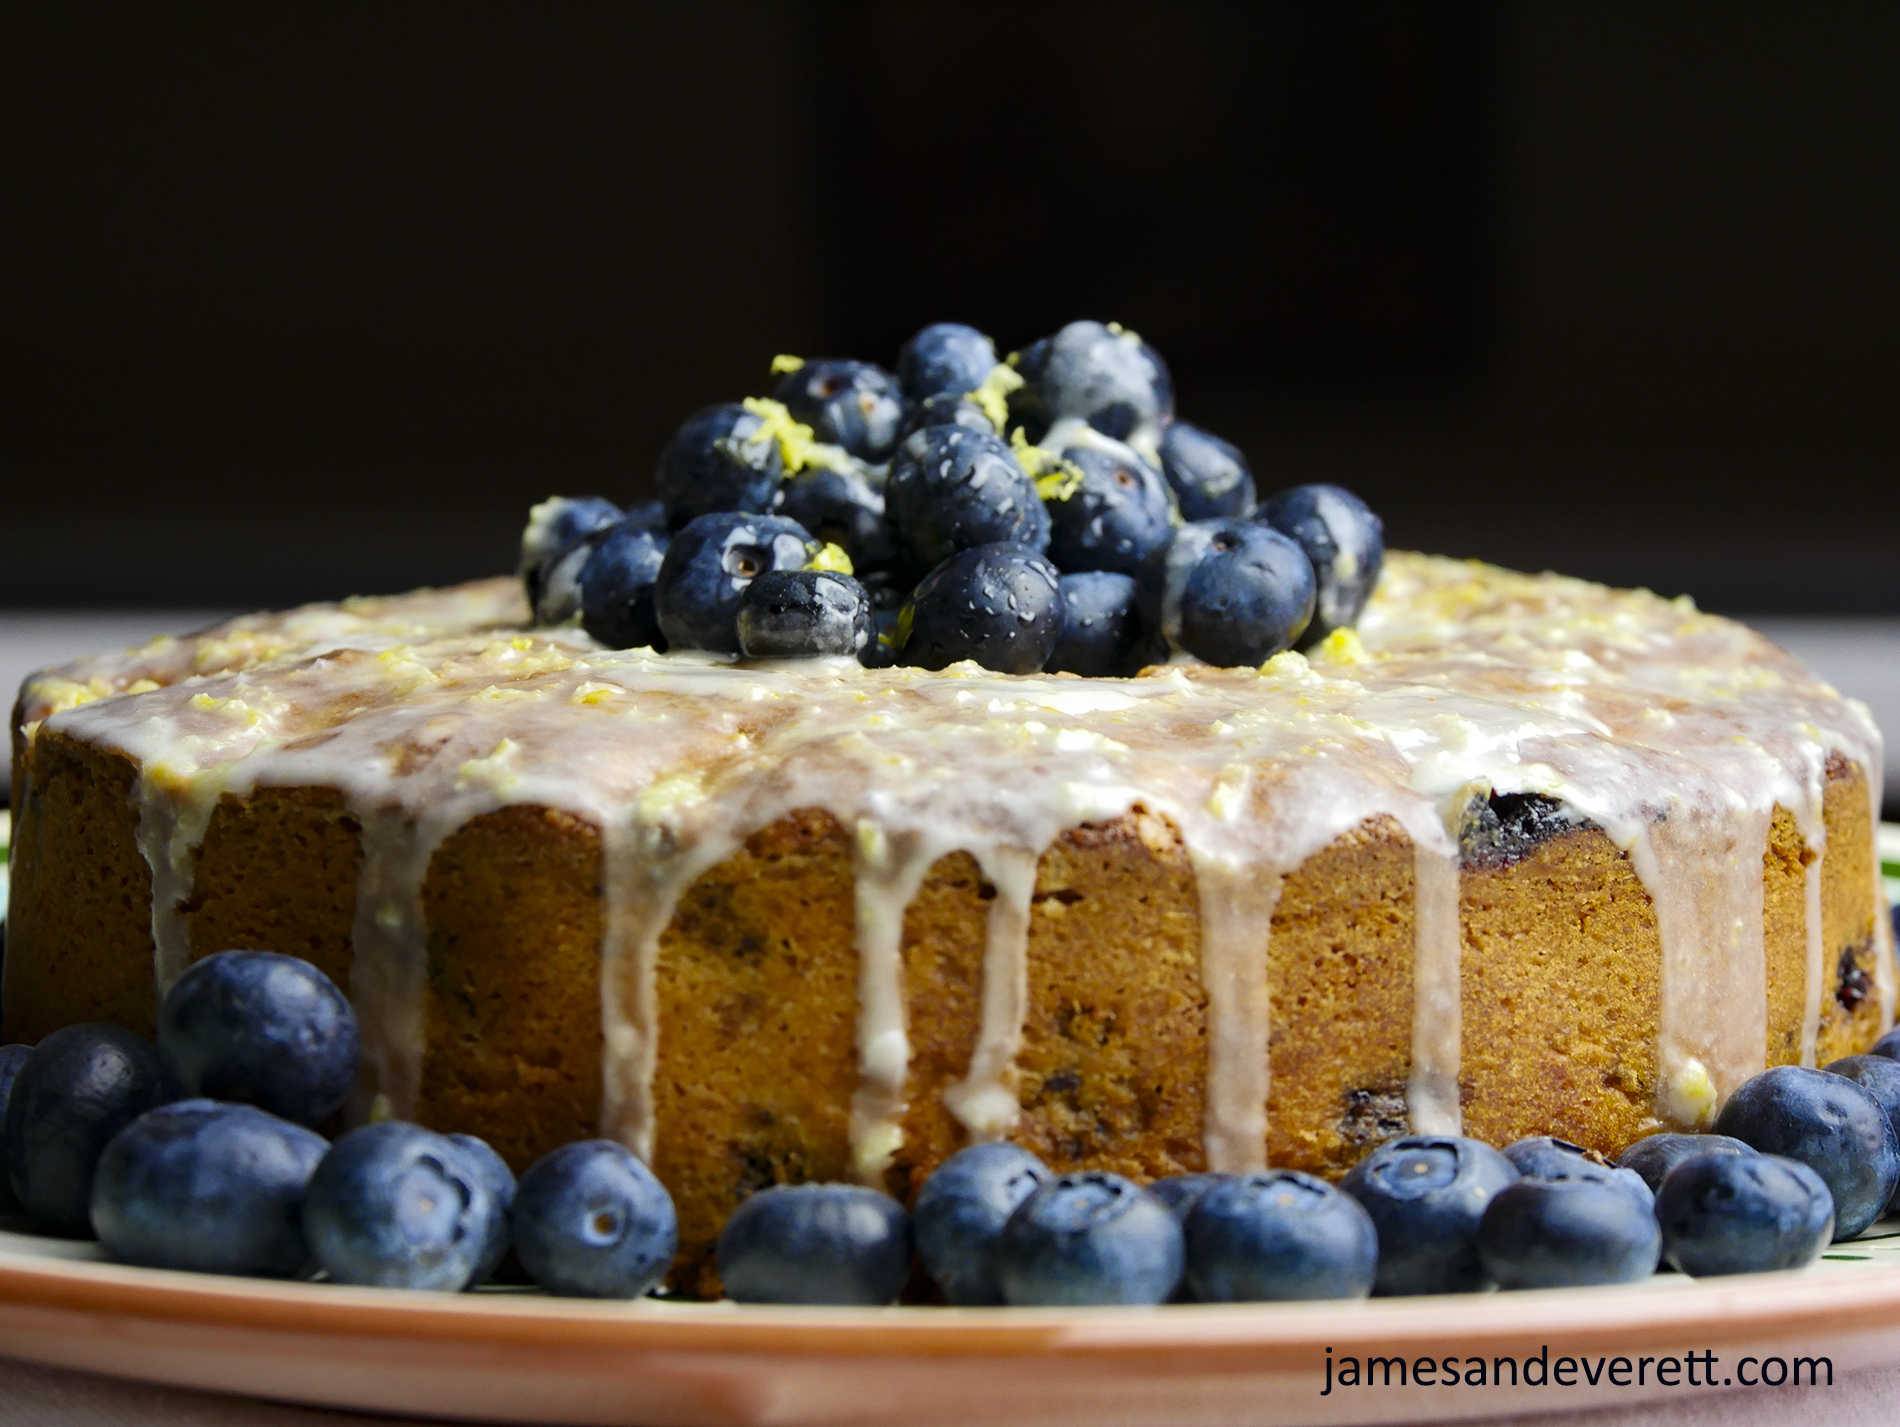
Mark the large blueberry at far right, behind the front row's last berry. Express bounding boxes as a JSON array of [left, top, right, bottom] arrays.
[[1716, 1066, 1900, 1239]]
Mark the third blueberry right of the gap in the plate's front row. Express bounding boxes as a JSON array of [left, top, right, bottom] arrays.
[[996, 1170, 1186, 1307]]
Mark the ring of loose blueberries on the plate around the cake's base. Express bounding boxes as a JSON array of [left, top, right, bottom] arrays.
[[0, 952, 1900, 1305]]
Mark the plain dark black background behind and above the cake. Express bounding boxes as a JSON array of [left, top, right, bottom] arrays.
[[0, 0, 1900, 612]]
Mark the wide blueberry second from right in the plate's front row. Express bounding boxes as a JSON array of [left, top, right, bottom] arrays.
[[1478, 1167, 1663, 1288]]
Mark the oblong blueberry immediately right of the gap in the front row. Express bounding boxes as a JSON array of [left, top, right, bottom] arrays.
[[718, 1184, 910, 1307]]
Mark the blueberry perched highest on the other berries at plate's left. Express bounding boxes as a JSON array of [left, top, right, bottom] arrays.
[[158, 952, 363, 1125]]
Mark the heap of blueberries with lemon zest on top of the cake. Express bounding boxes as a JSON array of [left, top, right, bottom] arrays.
[[521, 321, 1385, 676]]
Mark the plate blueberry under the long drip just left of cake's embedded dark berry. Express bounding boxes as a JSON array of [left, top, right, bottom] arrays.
[[1340, 1134, 1518, 1294]]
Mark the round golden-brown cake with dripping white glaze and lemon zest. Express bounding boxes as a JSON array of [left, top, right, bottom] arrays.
[[4, 553, 1894, 1294]]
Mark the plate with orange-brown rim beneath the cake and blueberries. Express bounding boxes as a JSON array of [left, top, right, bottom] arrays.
[[0, 1220, 1900, 1427]]
